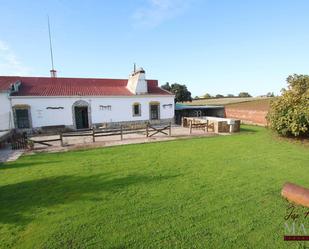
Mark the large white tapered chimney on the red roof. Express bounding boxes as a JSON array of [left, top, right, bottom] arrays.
[[127, 67, 148, 94]]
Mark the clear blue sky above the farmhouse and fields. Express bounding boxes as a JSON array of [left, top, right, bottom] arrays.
[[0, 0, 309, 96]]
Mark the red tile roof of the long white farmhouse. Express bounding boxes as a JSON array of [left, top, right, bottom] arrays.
[[0, 76, 171, 96]]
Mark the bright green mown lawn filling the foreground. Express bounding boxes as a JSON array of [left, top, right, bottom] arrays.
[[0, 126, 309, 249]]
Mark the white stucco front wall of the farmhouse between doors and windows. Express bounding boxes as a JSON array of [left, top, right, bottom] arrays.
[[12, 95, 175, 127]]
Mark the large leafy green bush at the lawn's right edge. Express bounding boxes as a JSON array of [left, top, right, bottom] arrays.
[[267, 74, 309, 136]]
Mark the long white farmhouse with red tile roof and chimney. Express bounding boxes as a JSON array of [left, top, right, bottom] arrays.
[[0, 68, 174, 131]]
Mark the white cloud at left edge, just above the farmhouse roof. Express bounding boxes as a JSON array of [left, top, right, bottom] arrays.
[[0, 40, 30, 75]]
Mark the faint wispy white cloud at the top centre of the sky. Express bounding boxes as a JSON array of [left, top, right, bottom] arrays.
[[133, 0, 192, 27]]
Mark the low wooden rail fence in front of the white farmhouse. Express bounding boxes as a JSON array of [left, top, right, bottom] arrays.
[[11, 123, 172, 149]]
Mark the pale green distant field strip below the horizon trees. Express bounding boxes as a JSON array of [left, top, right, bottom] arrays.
[[186, 97, 270, 105]]
